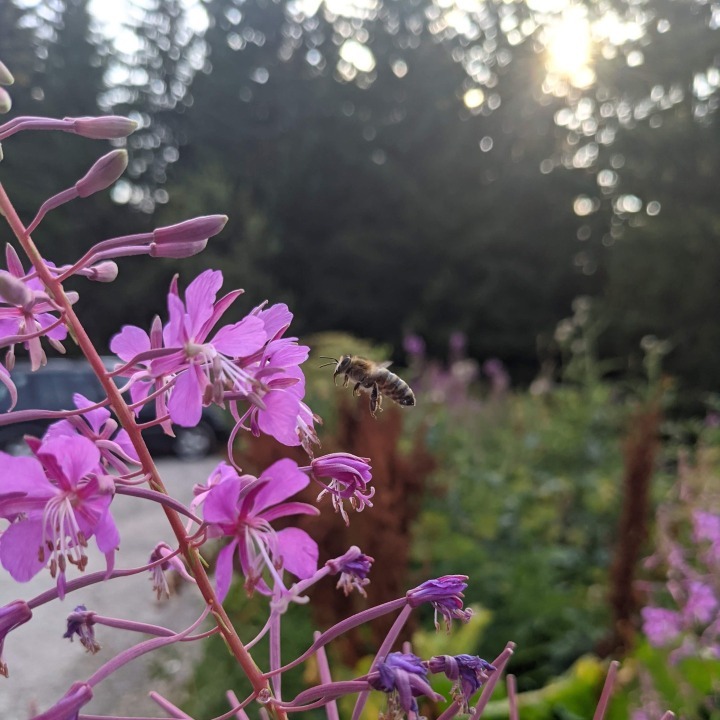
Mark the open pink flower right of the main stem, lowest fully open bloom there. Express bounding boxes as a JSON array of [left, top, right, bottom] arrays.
[[203, 459, 318, 600]]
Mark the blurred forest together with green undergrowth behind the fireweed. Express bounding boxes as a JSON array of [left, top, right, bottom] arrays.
[[0, 0, 720, 720]]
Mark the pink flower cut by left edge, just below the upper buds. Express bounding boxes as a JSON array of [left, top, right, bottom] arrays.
[[0, 245, 78, 370]]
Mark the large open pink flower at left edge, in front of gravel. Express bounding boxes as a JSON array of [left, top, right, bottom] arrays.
[[0, 436, 120, 598]]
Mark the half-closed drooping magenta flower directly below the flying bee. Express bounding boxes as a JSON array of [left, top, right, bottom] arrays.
[[303, 453, 375, 525]]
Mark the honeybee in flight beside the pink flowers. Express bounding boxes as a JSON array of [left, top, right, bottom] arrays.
[[320, 355, 415, 417]]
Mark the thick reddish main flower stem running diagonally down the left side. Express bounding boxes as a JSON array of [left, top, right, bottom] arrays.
[[0, 183, 276, 718]]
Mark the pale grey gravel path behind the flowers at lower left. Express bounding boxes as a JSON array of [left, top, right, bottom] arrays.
[[0, 457, 219, 720]]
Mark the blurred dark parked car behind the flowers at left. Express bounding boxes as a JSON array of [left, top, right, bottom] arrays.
[[0, 359, 228, 459]]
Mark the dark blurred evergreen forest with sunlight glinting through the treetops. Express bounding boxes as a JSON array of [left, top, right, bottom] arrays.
[[0, 0, 720, 391]]
